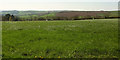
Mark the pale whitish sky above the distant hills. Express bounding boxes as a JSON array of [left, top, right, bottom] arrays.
[[0, 0, 119, 11]]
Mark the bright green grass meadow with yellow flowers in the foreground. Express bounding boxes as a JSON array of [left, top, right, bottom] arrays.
[[2, 19, 118, 58]]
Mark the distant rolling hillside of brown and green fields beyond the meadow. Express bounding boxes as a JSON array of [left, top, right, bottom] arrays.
[[0, 10, 120, 21]]
